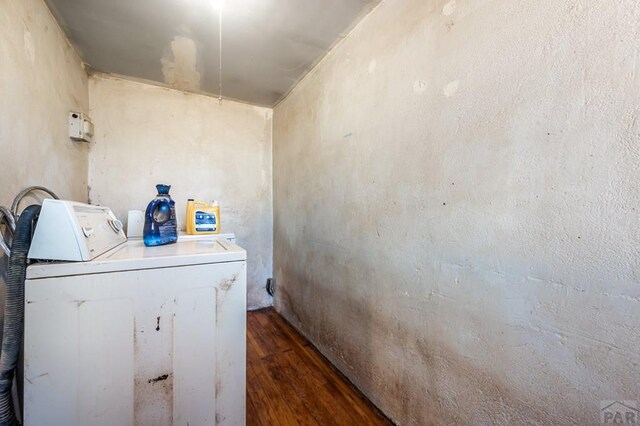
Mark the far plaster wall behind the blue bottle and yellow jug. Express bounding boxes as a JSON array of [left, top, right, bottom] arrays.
[[89, 75, 273, 309]]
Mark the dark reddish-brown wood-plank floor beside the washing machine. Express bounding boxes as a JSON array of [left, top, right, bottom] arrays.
[[247, 308, 391, 426]]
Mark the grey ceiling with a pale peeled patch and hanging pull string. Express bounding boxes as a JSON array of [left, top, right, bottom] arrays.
[[46, 0, 380, 106]]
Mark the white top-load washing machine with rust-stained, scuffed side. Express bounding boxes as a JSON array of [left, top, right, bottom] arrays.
[[24, 203, 246, 426]]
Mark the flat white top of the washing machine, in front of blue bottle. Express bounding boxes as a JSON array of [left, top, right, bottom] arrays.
[[27, 239, 247, 279]]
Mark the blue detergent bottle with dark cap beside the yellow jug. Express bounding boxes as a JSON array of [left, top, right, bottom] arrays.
[[142, 184, 178, 247]]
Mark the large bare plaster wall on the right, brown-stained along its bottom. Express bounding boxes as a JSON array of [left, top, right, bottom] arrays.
[[274, 0, 640, 425]]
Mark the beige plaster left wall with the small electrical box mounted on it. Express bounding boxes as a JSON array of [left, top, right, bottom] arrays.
[[0, 0, 89, 206]]
